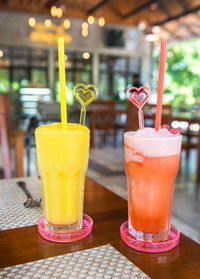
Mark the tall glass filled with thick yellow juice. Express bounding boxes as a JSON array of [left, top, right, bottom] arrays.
[[35, 123, 90, 233]]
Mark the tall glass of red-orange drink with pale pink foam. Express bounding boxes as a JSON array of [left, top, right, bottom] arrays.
[[124, 128, 182, 242]]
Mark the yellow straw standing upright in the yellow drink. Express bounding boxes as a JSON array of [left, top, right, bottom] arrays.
[[58, 37, 67, 129]]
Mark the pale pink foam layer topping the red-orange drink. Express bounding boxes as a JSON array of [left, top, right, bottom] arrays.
[[124, 128, 181, 161]]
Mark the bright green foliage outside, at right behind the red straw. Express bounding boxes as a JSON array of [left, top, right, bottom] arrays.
[[153, 39, 200, 111]]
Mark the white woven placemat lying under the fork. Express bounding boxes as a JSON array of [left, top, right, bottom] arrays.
[[0, 177, 42, 230]]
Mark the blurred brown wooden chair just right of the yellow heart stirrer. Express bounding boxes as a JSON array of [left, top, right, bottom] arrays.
[[90, 100, 116, 147]]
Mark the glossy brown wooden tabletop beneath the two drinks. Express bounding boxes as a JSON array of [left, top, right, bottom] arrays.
[[0, 178, 200, 279]]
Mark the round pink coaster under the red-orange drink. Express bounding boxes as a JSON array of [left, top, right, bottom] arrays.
[[120, 221, 180, 255]]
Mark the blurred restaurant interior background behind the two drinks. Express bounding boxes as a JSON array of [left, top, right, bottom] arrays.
[[0, 0, 200, 278]]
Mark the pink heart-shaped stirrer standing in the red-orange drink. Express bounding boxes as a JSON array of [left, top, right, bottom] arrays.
[[126, 86, 151, 129]]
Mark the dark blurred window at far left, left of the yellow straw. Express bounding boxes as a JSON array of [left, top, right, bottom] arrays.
[[0, 47, 48, 92]]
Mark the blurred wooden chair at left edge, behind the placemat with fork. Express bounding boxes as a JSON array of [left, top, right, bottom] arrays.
[[0, 95, 26, 178]]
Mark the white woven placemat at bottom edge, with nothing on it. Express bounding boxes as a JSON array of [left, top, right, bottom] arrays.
[[0, 244, 150, 279]]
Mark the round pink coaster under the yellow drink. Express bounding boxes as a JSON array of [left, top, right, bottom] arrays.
[[37, 214, 93, 242]]
